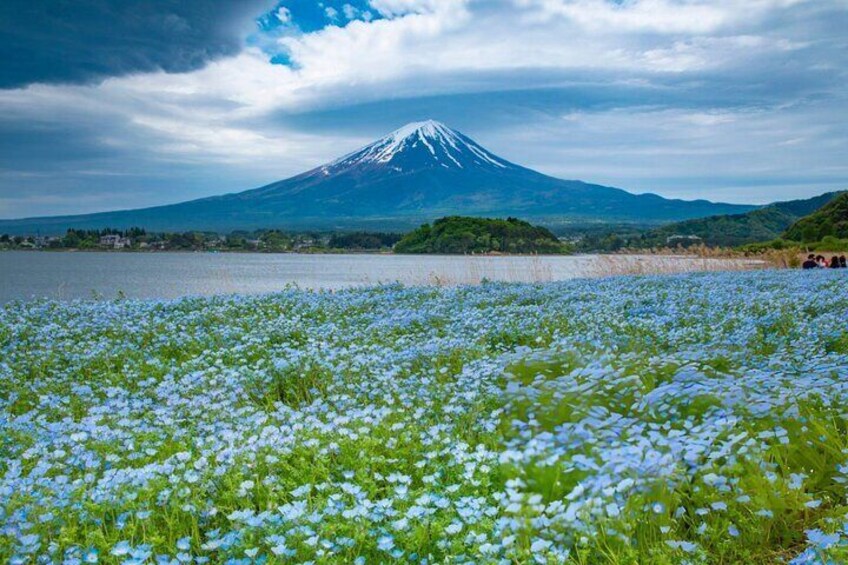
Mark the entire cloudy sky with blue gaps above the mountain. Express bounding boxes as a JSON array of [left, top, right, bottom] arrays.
[[0, 0, 848, 218]]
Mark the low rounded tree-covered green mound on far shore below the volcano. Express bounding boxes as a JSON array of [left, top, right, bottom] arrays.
[[395, 216, 569, 254]]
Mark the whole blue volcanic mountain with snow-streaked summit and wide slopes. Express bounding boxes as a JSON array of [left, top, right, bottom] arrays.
[[0, 120, 755, 234]]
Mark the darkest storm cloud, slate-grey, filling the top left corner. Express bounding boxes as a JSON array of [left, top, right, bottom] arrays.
[[0, 0, 273, 88]]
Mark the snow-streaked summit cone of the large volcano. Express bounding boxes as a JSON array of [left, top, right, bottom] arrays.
[[327, 120, 511, 171]]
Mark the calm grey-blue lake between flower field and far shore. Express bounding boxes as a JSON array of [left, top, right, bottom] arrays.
[[0, 251, 756, 303]]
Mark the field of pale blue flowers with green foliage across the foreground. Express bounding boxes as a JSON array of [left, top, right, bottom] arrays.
[[0, 270, 848, 564]]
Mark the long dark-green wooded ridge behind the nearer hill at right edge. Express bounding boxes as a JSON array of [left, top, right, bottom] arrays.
[[643, 192, 847, 247]]
